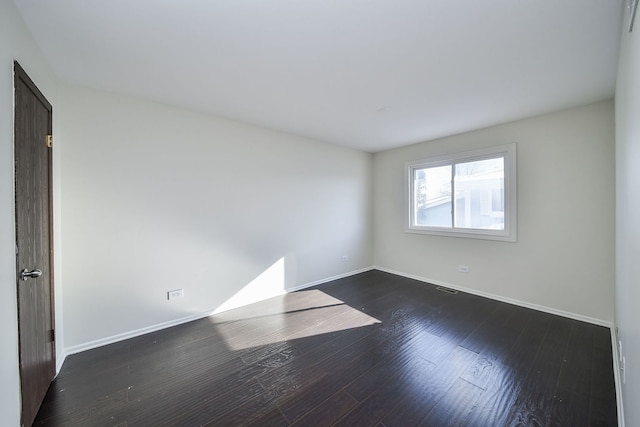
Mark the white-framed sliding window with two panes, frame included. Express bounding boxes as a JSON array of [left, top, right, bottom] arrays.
[[406, 144, 516, 242]]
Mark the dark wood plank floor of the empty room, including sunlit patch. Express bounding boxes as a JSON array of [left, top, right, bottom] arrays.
[[35, 271, 617, 427]]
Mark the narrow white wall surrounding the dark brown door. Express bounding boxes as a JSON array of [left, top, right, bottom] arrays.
[[0, 0, 62, 426]]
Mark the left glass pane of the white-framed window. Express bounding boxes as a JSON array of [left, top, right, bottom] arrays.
[[413, 165, 452, 227]]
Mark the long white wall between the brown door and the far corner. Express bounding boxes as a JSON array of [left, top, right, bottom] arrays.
[[60, 87, 372, 351]]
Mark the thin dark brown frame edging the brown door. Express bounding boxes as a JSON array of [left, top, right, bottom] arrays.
[[13, 61, 57, 425]]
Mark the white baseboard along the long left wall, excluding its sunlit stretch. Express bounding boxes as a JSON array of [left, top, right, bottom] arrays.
[[63, 267, 373, 358]]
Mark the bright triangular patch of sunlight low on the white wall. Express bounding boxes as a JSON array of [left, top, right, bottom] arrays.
[[214, 257, 285, 314]]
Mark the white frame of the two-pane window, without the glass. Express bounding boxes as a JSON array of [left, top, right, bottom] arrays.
[[405, 143, 518, 242]]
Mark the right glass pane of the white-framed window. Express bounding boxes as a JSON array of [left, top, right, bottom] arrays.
[[454, 157, 504, 230]]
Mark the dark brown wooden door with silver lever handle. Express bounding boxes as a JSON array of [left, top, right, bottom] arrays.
[[14, 62, 55, 426]]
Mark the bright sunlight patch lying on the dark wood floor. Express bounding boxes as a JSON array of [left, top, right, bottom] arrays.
[[210, 289, 380, 350]]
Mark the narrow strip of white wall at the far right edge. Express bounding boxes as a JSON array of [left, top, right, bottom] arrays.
[[616, 12, 640, 426]]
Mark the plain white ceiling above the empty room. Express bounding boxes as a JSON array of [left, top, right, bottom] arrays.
[[14, 0, 624, 152]]
